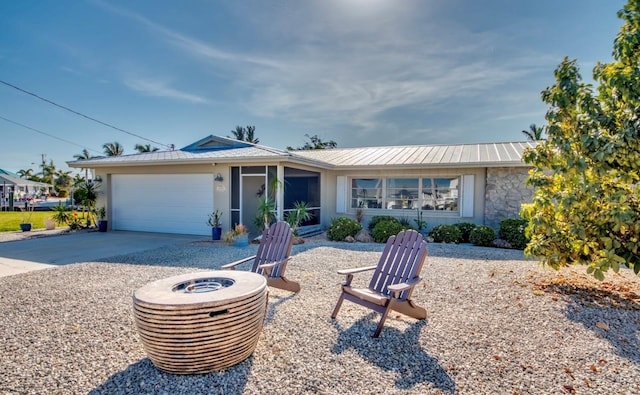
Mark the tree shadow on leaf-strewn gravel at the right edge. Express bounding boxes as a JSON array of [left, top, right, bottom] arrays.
[[537, 280, 640, 364]]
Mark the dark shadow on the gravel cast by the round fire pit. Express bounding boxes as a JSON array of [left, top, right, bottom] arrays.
[[89, 357, 253, 395]]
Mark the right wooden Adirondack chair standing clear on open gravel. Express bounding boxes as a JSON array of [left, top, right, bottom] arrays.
[[331, 230, 427, 337]]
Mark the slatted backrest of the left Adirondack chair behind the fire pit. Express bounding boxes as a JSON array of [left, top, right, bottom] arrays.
[[251, 221, 293, 277]]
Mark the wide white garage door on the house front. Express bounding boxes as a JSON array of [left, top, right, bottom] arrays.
[[110, 174, 213, 235]]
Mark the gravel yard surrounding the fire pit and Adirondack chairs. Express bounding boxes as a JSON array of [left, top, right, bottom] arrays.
[[0, 237, 640, 394]]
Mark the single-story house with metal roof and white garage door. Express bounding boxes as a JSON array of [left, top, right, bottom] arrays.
[[68, 136, 535, 235]]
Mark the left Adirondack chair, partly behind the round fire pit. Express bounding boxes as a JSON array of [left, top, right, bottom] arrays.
[[222, 221, 300, 292]]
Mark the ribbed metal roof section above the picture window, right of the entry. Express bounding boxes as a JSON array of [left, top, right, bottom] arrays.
[[294, 141, 536, 168]]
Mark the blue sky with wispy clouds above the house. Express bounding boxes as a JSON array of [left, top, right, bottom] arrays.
[[0, 0, 625, 174]]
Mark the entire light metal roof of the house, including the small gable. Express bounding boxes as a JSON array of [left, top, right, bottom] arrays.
[[67, 136, 536, 169]]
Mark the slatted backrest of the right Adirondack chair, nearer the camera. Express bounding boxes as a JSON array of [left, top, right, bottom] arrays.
[[369, 229, 427, 300]]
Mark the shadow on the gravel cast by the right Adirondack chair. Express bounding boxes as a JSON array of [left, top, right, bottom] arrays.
[[332, 313, 456, 393]]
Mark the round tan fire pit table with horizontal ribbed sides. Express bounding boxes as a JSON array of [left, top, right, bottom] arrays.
[[133, 270, 268, 374]]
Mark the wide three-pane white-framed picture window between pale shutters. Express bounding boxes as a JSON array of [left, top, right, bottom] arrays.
[[351, 176, 460, 212]]
